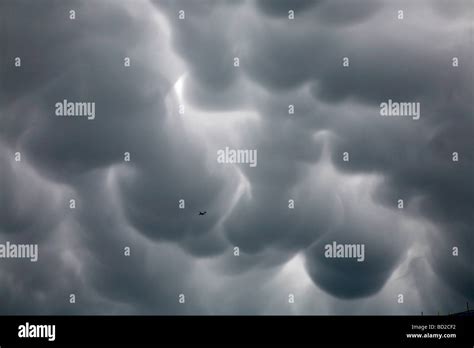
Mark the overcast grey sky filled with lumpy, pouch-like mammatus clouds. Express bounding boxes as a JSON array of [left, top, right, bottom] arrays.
[[0, 0, 474, 314]]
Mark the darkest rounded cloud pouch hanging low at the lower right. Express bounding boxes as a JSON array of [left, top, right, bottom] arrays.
[[306, 207, 408, 298]]
